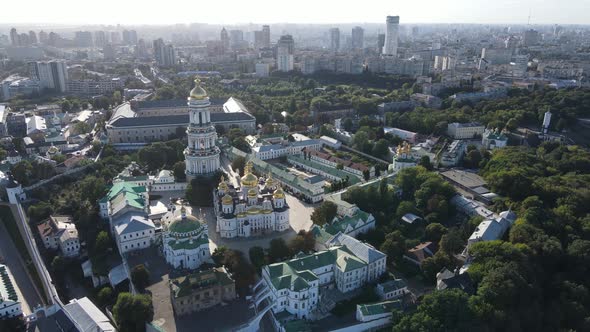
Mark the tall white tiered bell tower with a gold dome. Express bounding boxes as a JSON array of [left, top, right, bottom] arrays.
[[184, 78, 220, 181]]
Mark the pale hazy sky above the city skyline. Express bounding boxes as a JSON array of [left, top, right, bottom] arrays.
[[0, 0, 590, 25]]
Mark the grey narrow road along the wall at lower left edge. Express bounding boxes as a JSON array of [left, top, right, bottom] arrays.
[[0, 218, 42, 315]]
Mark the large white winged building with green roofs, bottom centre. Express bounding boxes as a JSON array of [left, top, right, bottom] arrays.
[[253, 234, 387, 319]]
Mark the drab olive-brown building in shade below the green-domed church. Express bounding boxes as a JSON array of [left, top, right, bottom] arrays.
[[169, 267, 236, 316]]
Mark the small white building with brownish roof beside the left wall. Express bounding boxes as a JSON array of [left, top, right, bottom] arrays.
[[37, 216, 80, 257]]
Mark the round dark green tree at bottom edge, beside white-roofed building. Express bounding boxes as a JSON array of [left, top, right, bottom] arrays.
[[113, 293, 154, 332]]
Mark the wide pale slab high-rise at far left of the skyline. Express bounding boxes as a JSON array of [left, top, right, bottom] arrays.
[[28, 60, 68, 92]]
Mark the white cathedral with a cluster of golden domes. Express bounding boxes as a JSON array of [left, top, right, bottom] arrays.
[[213, 162, 290, 238]]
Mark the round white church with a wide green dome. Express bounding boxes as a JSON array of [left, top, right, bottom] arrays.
[[162, 206, 211, 270]]
